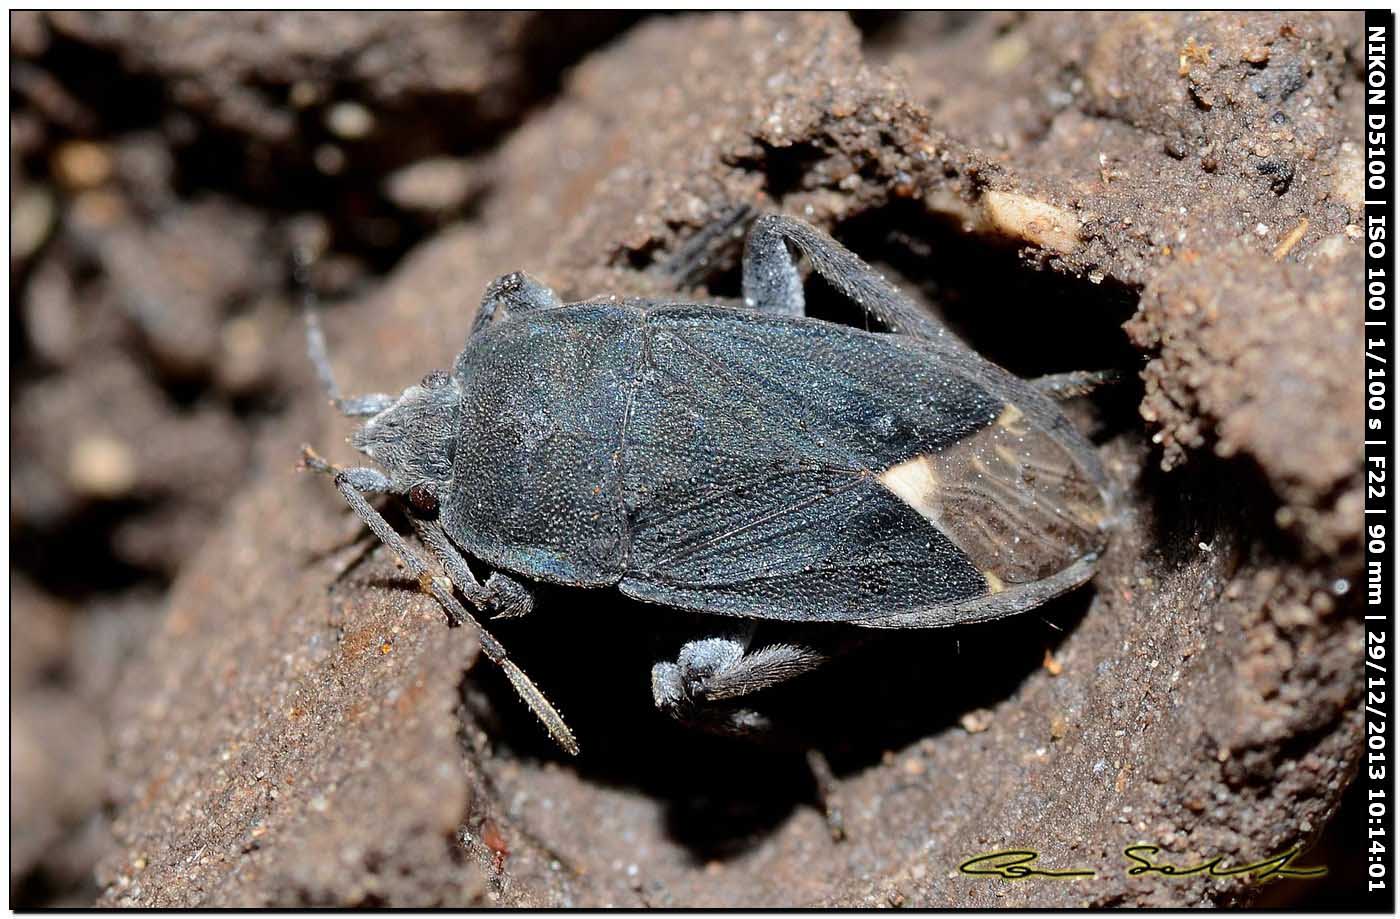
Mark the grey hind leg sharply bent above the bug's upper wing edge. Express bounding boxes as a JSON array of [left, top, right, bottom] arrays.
[[743, 214, 952, 340]]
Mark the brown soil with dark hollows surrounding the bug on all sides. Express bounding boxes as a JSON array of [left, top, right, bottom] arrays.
[[10, 13, 1362, 906]]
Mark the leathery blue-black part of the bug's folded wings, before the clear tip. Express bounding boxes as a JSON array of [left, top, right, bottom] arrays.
[[622, 311, 1000, 621]]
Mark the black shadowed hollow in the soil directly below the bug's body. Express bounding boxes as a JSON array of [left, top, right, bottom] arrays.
[[463, 587, 1092, 863]]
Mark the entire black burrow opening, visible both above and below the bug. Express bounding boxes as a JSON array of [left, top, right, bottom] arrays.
[[463, 198, 1141, 863]]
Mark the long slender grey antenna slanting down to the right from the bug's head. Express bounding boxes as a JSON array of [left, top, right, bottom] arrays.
[[302, 448, 578, 754]]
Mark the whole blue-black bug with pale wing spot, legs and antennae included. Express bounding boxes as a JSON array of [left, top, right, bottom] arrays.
[[307, 216, 1109, 752]]
